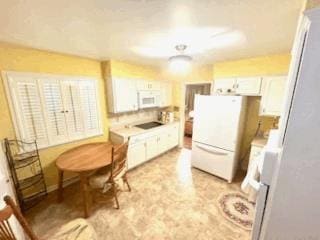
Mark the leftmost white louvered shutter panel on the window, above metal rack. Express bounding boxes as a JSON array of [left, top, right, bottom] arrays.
[[9, 77, 48, 147]]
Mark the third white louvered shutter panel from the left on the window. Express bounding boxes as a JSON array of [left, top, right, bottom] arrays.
[[61, 80, 85, 139]]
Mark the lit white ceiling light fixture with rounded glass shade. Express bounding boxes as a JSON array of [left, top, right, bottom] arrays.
[[169, 44, 192, 73]]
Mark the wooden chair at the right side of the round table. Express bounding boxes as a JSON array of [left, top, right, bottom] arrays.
[[89, 140, 131, 209]]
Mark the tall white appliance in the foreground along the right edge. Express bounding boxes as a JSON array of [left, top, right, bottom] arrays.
[[252, 8, 320, 240]]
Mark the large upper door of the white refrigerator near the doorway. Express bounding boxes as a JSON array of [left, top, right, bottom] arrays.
[[193, 95, 243, 151]]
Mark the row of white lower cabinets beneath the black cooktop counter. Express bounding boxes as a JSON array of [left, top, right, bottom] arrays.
[[128, 123, 179, 169]]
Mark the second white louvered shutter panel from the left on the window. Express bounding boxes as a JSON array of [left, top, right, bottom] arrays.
[[39, 79, 68, 144]]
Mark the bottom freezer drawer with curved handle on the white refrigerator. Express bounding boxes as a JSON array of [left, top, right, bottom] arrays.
[[191, 142, 235, 182]]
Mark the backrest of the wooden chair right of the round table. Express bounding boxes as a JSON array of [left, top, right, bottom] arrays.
[[111, 140, 129, 177]]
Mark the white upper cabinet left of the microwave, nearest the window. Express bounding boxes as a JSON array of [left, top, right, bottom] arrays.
[[108, 77, 138, 113]]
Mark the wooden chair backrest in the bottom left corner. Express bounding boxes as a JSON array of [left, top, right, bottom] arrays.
[[0, 196, 39, 240]]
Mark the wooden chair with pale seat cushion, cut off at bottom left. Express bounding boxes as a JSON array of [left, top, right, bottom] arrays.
[[0, 196, 97, 240]]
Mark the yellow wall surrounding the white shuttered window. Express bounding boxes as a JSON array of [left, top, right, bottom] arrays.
[[0, 43, 108, 186]]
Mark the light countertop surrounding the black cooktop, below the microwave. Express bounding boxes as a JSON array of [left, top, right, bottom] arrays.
[[110, 120, 179, 138]]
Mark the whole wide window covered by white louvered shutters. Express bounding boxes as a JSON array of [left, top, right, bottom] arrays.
[[5, 72, 102, 148]]
